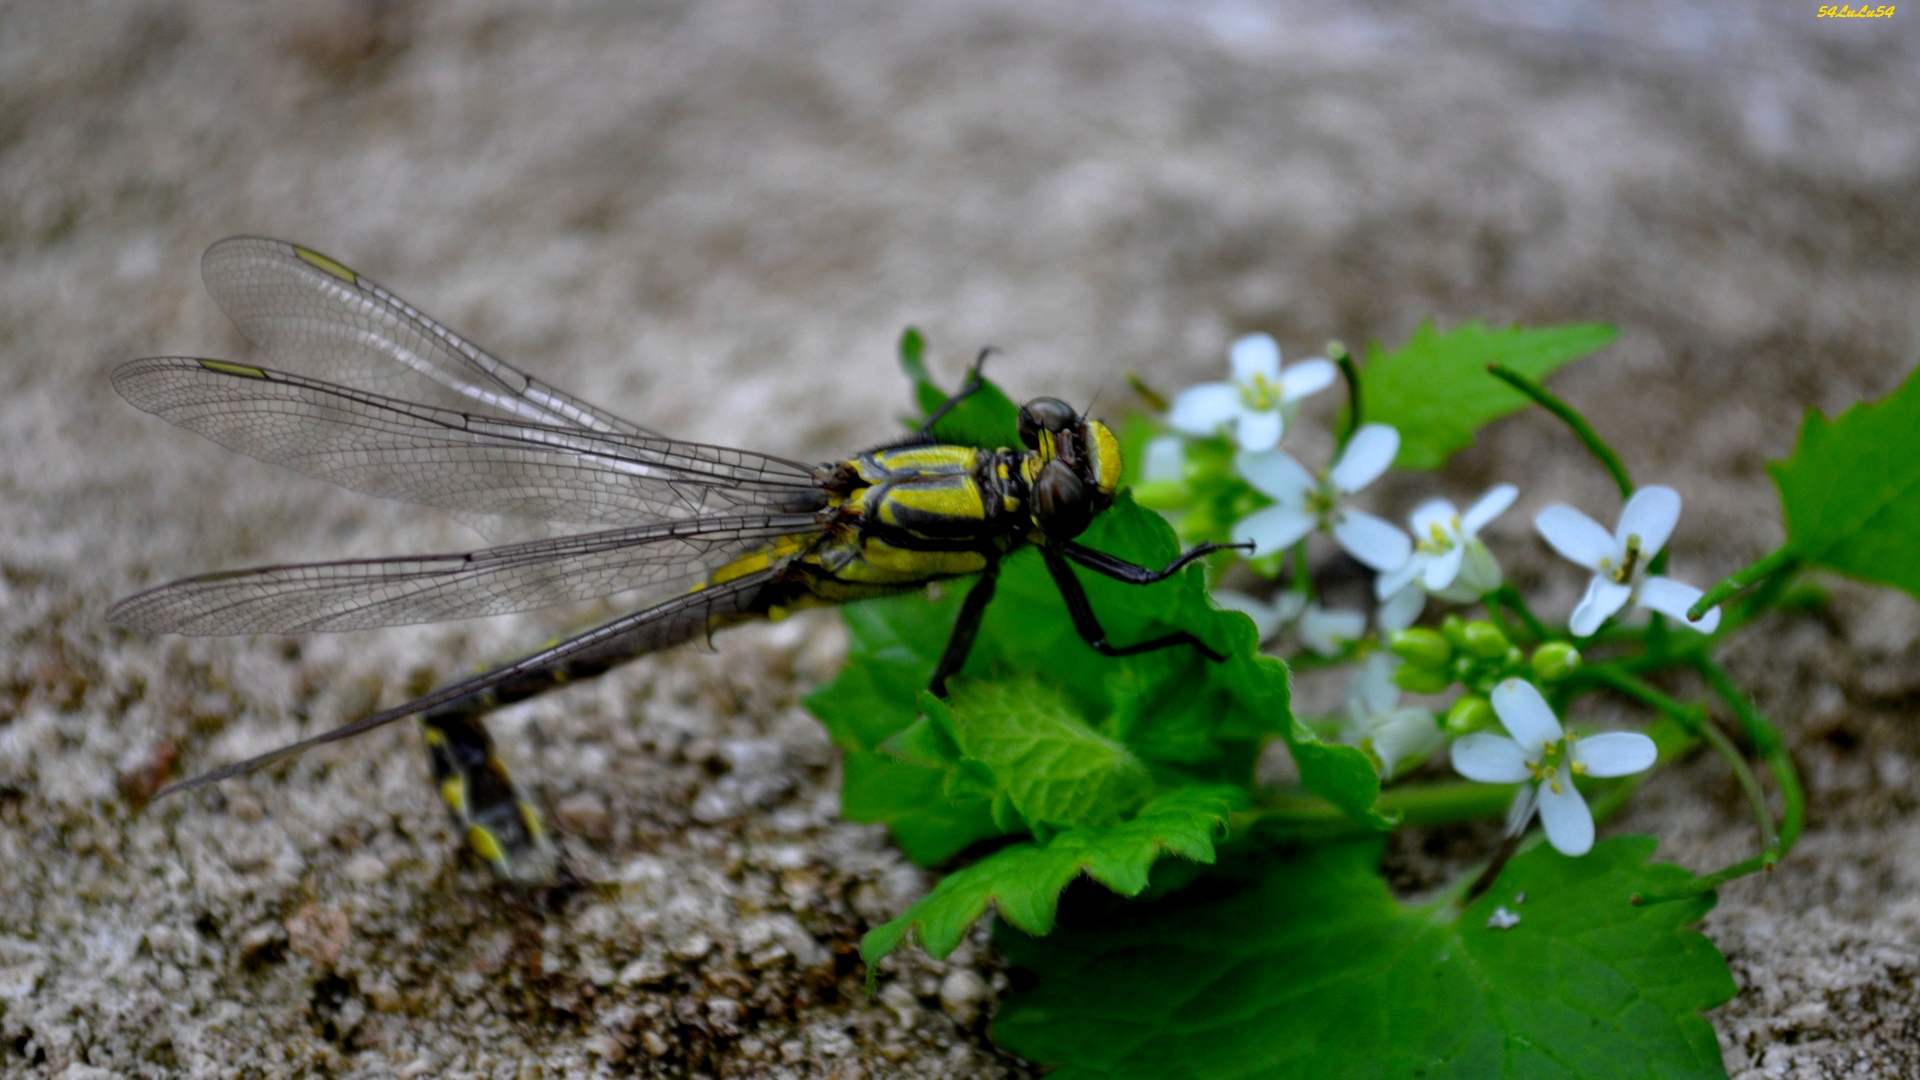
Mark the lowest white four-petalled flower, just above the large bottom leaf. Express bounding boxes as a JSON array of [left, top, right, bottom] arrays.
[[1453, 678, 1659, 855]]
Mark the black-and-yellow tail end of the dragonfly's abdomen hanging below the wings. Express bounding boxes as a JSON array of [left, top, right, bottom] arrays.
[[420, 701, 564, 886]]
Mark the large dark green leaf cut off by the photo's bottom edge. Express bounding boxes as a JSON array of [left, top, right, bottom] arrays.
[[998, 836, 1734, 1080]]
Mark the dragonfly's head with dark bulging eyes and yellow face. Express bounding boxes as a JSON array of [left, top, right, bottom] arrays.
[[1020, 398, 1119, 540]]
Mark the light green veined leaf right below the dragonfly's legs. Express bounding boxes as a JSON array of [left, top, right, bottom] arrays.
[[948, 678, 1152, 826]]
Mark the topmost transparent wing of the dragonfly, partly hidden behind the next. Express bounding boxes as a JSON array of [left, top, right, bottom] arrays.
[[200, 236, 653, 434]]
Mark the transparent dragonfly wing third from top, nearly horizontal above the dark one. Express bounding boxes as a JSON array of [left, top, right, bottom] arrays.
[[108, 513, 824, 634]]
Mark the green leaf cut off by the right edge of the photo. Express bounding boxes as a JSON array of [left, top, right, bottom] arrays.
[[1766, 361, 1920, 596]]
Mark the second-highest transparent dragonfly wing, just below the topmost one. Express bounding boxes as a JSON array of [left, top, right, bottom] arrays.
[[113, 357, 826, 527]]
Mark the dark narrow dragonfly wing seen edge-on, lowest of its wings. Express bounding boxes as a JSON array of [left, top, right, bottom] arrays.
[[156, 569, 778, 798]]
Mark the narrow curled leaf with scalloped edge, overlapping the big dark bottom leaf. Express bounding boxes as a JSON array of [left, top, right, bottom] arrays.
[[860, 786, 1246, 957]]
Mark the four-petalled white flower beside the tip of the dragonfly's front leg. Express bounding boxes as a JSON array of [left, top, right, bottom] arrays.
[[1233, 425, 1413, 571]]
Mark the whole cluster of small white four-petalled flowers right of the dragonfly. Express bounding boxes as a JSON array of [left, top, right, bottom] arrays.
[[1144, 334, 1720, 855]]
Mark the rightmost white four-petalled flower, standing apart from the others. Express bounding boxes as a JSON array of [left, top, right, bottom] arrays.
[[1534, 488, 1720, 638]]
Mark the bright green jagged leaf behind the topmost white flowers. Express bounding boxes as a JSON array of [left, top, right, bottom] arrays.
[[1361, 321, 1619, 469]]
